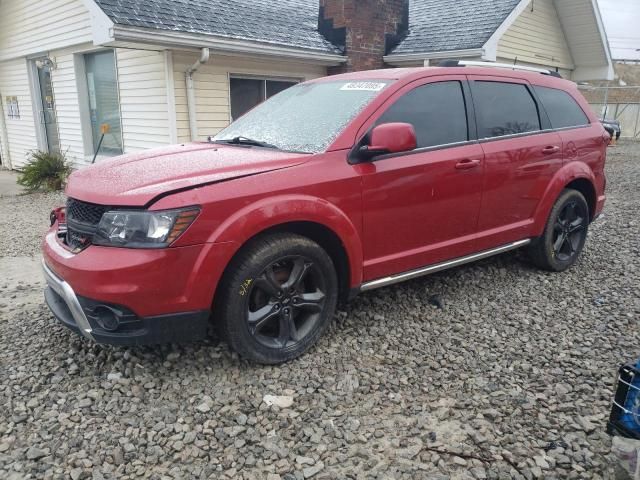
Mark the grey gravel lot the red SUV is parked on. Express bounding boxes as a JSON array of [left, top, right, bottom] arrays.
[[0, 144, 640, 480]]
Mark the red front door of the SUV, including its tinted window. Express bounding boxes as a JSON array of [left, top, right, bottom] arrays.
[[354, 76, 484, 281]]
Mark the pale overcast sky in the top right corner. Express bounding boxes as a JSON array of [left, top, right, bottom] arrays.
[[598, 0, 640, 60]]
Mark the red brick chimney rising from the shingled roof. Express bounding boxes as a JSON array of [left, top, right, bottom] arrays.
[[318, 0, 409, 75]]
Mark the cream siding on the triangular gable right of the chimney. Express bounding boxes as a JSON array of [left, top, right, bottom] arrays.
[[498, 0, 573, 70]]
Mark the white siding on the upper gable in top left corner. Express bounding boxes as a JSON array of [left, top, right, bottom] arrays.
[[0, 0, 91, 61]]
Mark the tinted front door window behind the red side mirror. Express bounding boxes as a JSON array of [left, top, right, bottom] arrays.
[[377, 82, 469, 148]]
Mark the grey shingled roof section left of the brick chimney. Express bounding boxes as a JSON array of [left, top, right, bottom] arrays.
[[95, 0, 341, 54]]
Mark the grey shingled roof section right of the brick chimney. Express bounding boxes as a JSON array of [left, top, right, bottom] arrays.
[[392, 0, 520, 55]]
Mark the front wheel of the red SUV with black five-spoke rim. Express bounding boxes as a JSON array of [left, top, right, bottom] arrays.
[[214, 233, 338, 364]]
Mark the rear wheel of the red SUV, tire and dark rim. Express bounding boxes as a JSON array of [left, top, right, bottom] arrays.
[[528, 189, 589, 272]]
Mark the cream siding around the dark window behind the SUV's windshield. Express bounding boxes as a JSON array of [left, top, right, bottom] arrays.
[[173, 53, 327, 142]]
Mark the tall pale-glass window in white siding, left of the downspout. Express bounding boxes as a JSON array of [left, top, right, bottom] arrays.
[[84, 50, 122, 155]]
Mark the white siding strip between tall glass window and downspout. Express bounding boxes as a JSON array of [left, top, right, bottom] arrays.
[[117, 49, 169, 153]]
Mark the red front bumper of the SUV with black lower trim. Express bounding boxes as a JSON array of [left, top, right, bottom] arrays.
[[42, 224, 236, 345]]
